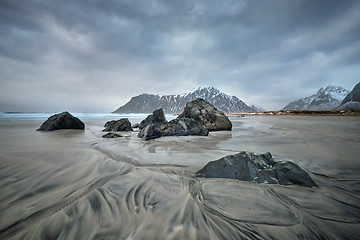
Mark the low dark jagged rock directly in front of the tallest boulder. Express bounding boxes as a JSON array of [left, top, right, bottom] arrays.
[[138, 118, 209, 140]]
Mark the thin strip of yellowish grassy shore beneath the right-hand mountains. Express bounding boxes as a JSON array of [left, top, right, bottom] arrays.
[[226, 110, 360, 116]]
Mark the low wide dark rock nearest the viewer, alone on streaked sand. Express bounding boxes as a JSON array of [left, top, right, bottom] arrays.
[[196, 152, 316, 187]]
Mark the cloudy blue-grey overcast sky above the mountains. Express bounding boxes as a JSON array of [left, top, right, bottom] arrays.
[[0, 0, 360, 112]]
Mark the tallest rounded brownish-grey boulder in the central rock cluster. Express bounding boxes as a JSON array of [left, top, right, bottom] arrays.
[[179, 98, 232, 131]]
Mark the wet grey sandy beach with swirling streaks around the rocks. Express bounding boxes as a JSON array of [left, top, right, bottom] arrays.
[[0, 116, 360, 239]]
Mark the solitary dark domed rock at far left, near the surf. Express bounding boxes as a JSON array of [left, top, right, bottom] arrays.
[[37, 112, 85, 131]]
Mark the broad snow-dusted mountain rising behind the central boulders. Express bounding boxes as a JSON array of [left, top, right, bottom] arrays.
[[114, 87, 259, 113]]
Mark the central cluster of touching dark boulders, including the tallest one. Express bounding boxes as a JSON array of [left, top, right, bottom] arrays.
[[138, 98, 232, 140]]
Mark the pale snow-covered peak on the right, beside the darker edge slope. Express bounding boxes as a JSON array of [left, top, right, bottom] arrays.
[[282, 85, 349, 110]]
